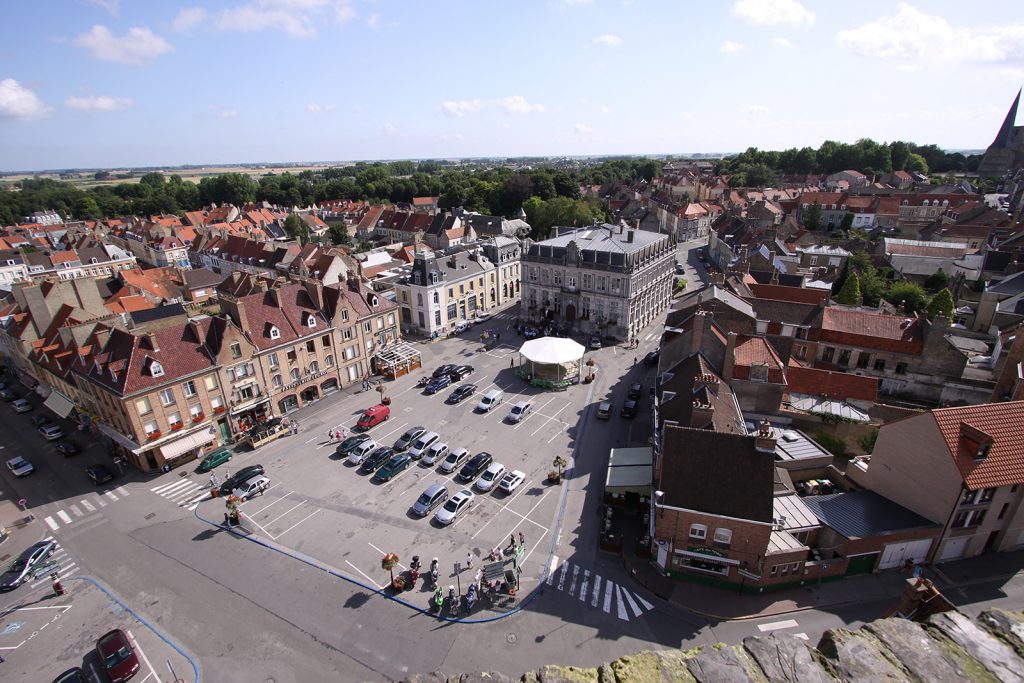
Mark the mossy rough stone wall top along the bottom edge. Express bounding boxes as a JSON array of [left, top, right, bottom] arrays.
[[406, 609, 1024, 683]]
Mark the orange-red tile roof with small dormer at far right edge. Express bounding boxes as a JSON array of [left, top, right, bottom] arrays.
[[931, 400, 1024, 490]]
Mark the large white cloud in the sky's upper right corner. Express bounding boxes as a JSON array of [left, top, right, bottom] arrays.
[[836, 2, 1024, 63]]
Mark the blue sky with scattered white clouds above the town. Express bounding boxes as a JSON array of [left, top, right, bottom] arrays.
[[0, 0, 1024, 171]]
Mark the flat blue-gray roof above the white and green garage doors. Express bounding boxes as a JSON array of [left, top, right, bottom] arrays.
[[804, 490, 939, 539]]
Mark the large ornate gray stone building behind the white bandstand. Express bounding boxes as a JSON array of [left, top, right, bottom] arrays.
[[522, 224, 676, 339]]
